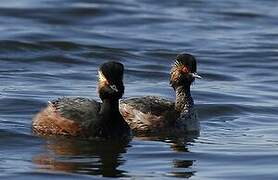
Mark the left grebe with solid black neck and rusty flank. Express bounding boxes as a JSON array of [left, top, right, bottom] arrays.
[[32, 62, 130, 139]]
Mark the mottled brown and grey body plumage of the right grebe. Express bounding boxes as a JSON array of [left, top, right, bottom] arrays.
[[120, 96, 175, 133]]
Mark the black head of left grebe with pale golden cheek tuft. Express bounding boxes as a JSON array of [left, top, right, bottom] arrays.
[[98, 61, 124, 100]]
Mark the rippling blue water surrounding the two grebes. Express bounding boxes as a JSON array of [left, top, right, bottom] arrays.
[[0, 0, 278, 180]]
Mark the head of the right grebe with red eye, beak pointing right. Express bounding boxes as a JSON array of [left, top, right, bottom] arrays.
[[170, 53, 201, 88]]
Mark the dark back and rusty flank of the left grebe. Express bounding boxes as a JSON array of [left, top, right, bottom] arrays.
[[33, 97, 100, 136]]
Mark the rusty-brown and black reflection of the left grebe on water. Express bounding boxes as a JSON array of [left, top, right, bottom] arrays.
[[33, 138, 131, 177]]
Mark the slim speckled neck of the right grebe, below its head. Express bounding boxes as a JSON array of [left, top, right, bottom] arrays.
[[175, 85, 194, 113]]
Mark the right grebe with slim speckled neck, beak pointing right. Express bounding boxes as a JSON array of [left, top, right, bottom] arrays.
[[120, 54, 201, 135]]
